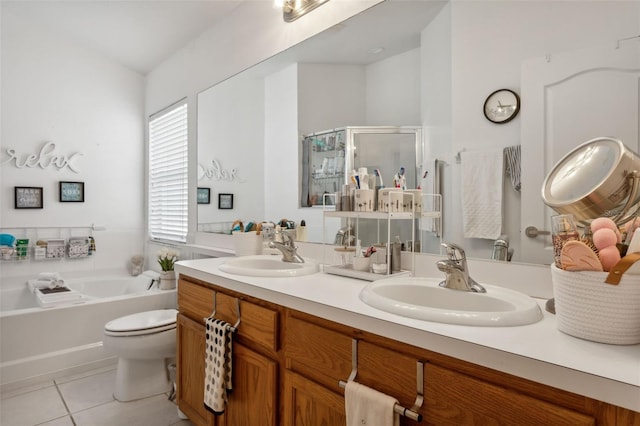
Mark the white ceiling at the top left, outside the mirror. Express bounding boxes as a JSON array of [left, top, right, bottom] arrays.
[[0, 0, 243, 75]]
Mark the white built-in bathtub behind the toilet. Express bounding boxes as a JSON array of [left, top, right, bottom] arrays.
[[0, 275, 176, 389]]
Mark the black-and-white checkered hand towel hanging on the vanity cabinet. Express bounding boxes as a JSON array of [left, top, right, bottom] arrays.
[[204, 318, 233, 415]]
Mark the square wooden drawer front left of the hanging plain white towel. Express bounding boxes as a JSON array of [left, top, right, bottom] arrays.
[[284, 312, 351, 392]]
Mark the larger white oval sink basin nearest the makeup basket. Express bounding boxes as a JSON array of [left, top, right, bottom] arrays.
[[360, 277, 542, 327]]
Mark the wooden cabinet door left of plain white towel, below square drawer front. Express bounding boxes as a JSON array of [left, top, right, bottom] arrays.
[[283, 371, 347, 426]]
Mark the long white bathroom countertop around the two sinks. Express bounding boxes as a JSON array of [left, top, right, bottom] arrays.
[[176, 258, 640, 412]]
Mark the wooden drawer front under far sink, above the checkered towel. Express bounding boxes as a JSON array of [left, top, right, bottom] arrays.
[[178, 278, 278, 352]]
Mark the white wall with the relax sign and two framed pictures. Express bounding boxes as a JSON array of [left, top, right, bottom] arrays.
[[0, 11, 145, 281]]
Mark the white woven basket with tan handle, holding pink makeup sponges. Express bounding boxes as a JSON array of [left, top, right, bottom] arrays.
[[551, 264, 640, 345]]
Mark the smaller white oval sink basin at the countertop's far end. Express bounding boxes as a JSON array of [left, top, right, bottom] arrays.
[[219, 255, 318, 277]]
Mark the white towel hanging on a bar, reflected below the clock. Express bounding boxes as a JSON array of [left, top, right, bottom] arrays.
[[460, 150, 504, 240]]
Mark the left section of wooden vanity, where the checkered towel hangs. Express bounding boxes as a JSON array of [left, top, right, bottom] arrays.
[[176, 277, 280, 426]]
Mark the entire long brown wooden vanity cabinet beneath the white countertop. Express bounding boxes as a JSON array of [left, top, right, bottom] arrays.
[[177, 277, 640, 426]]
